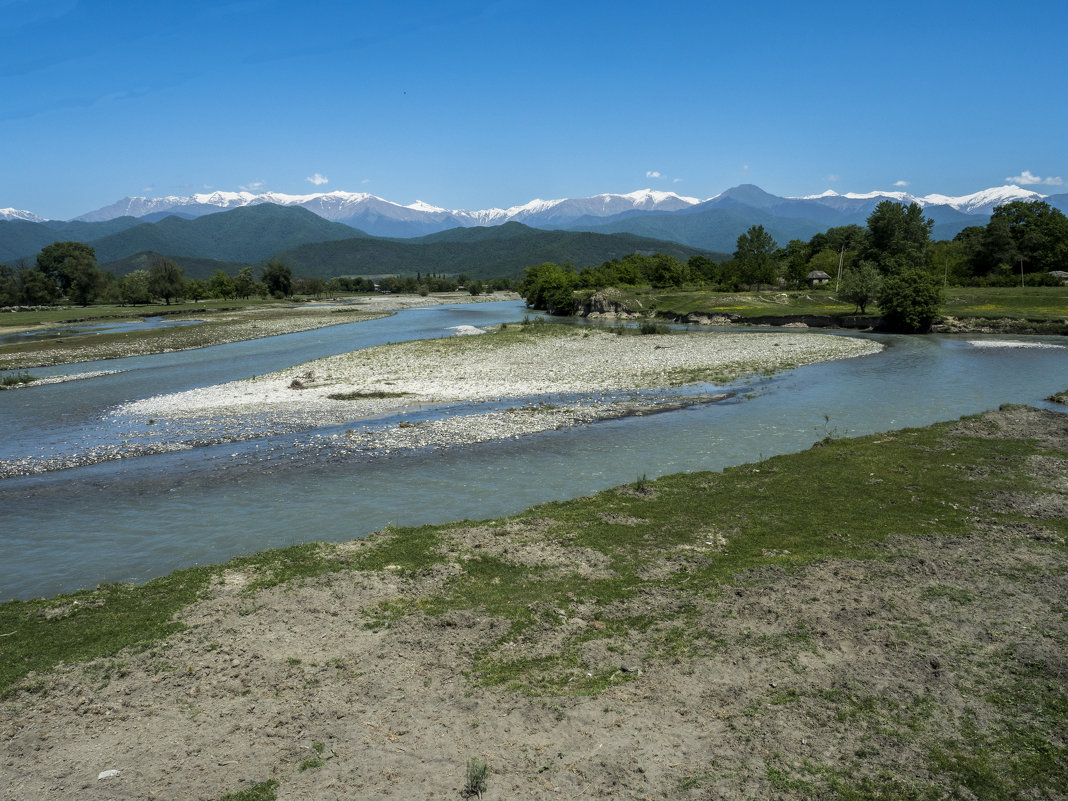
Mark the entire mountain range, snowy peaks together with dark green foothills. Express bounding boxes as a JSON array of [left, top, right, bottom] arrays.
[[0, 185, 1068, 276]]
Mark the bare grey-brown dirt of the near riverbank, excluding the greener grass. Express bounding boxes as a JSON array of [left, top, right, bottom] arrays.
[[0, 410, 1068, 801]]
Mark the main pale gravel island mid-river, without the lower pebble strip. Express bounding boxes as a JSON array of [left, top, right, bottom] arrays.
[[120, 327, 881, 423]]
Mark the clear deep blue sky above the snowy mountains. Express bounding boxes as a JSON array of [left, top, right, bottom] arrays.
[[0, 0, 1068, 219]]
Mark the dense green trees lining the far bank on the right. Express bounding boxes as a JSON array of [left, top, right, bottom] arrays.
[[520, 200, 1068, 330]]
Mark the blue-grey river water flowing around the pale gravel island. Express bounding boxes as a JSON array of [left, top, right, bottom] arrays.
[[0, 302, 1068, 599]]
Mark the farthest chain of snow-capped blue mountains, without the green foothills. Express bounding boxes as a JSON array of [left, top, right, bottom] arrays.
[[8, 184, 1055, 243]]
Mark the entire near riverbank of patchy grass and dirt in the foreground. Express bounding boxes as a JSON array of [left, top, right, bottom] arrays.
[[0, 407, 1068, 800]]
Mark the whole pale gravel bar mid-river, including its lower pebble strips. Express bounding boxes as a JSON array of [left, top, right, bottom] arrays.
[[0, 325, 881, 477]]
